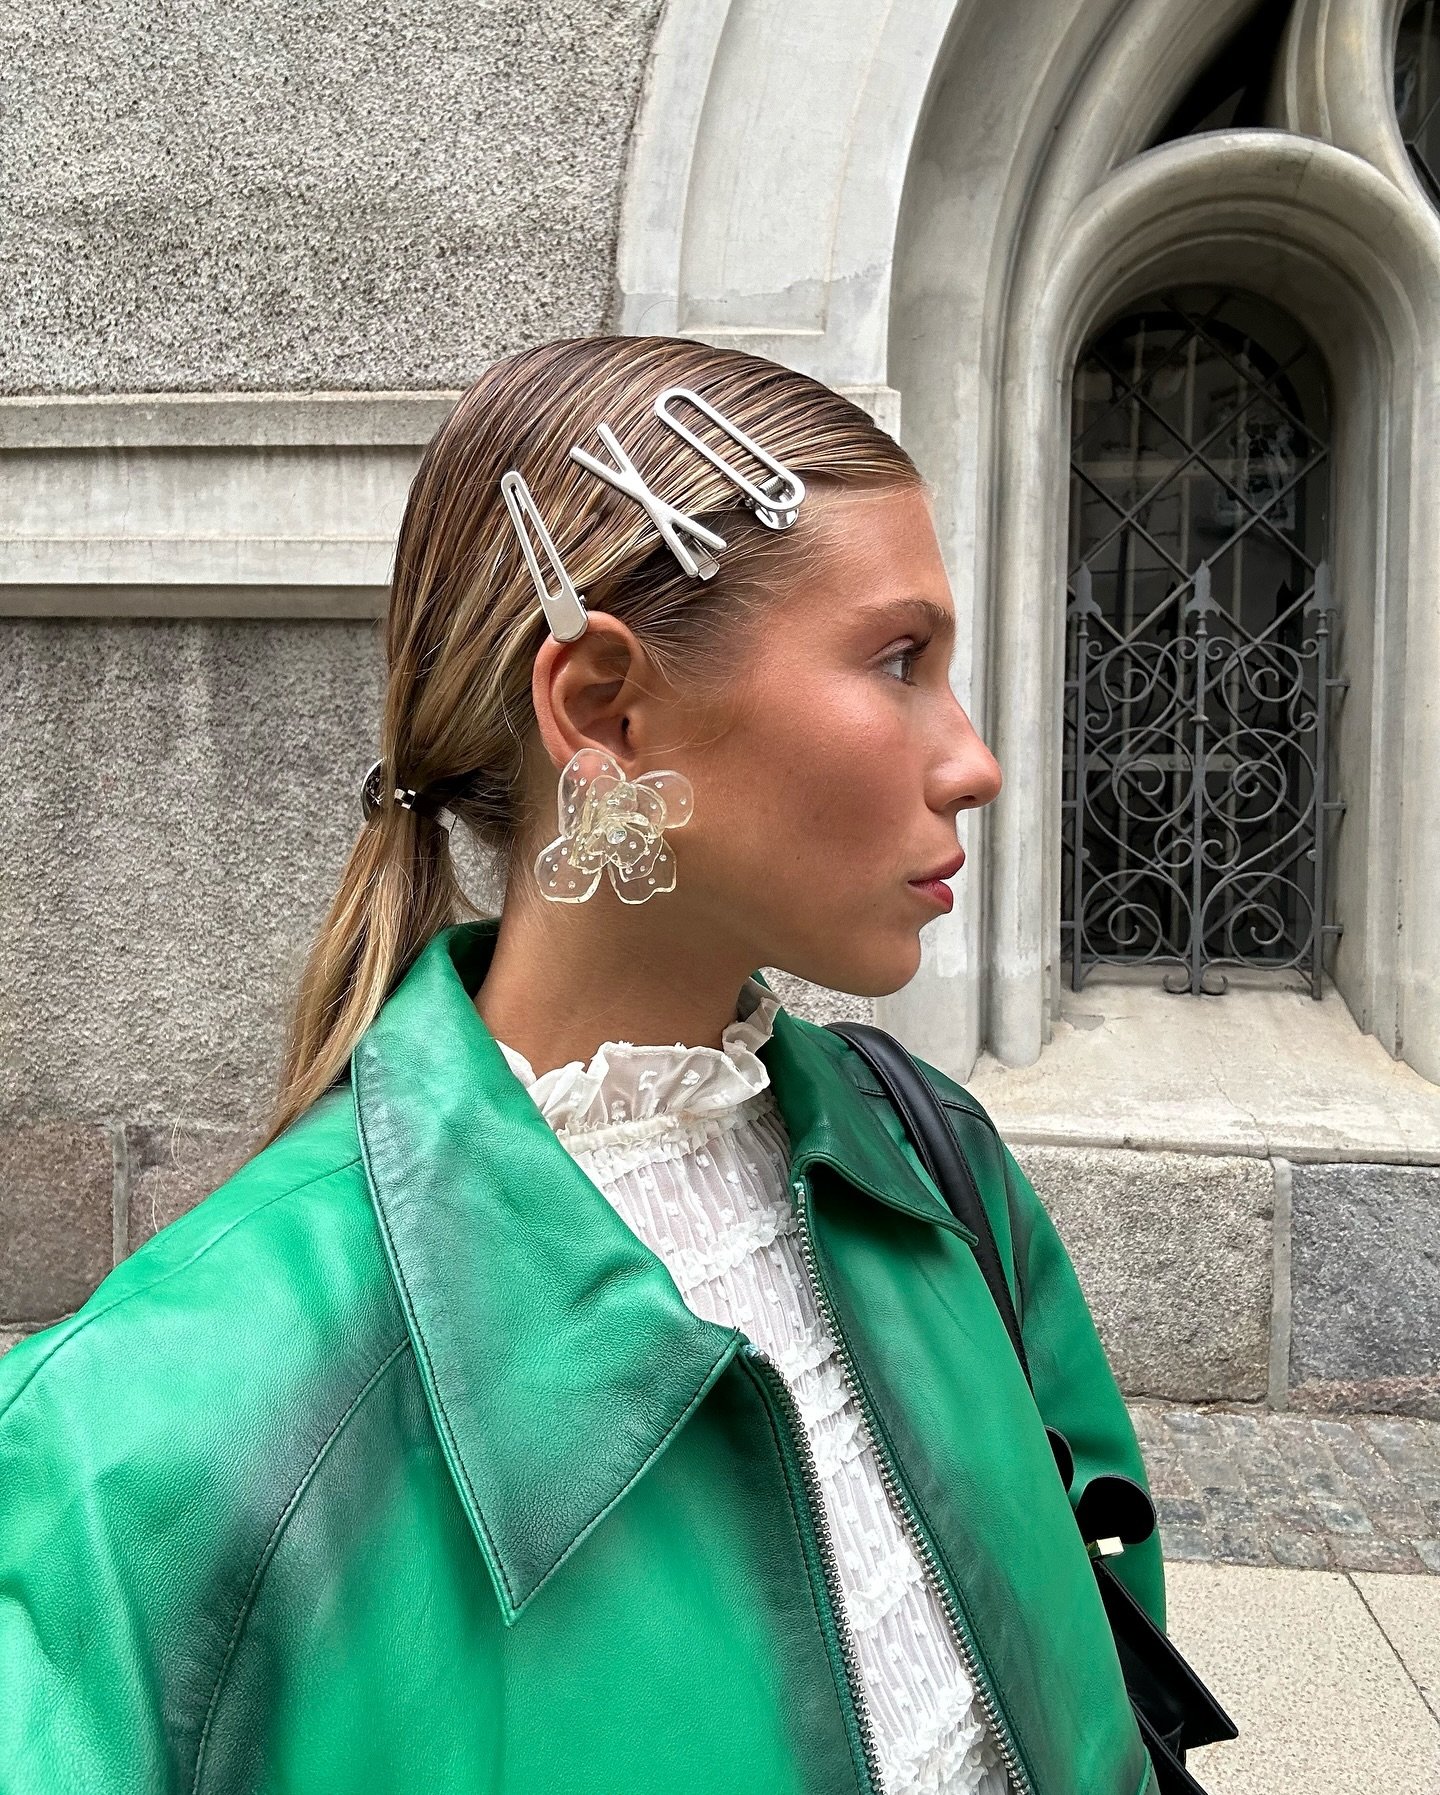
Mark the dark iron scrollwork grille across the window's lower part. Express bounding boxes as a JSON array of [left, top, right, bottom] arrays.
[[1063, 564, 1348, 998]]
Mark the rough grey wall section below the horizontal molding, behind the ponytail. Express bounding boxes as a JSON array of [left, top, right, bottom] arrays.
[[0, 619, 381, 1327]]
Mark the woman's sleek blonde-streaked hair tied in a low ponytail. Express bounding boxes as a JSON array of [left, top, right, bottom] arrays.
[[268, 336, 919, 1140]]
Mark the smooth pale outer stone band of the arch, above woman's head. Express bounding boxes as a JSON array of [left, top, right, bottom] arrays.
[[616, 0, 964, 400]]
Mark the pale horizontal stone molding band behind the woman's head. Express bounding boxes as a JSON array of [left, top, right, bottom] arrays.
[[0, 393, 456, 617]]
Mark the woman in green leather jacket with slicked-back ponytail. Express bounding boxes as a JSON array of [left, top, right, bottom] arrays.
[[0, 337, 1163, 1795]]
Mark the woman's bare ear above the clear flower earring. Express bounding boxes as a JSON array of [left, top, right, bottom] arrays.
[[530, 610, 663, 770]]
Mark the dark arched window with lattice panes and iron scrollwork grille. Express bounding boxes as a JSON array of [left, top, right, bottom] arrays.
[[1061, 287, 1343, 996]]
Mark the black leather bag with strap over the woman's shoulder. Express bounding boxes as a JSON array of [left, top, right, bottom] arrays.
[[830, 1021, 1239, 1795]]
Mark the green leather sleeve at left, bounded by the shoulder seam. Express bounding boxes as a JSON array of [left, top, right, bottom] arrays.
[[0, 1100, 384, 1795]]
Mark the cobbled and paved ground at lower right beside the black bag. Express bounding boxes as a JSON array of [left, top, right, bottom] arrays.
[[1129, 1402, 1440, 1795]]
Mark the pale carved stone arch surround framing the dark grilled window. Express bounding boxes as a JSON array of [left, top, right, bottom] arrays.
[[614, 0, 1440, 1079]]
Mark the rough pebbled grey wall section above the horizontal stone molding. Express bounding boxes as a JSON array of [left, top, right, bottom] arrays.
[[0, 0, 661, 393]]
